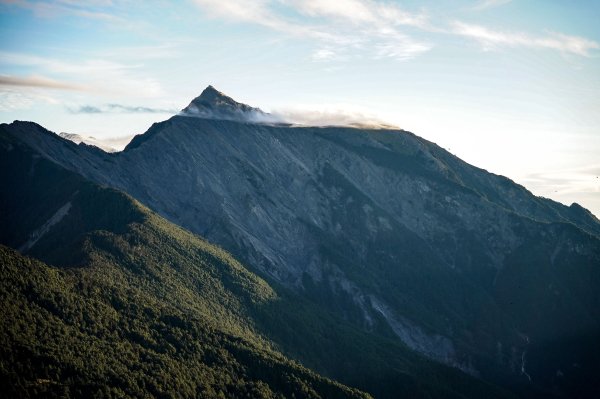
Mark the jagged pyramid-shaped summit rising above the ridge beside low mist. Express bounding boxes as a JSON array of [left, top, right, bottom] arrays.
[[180, 86, 276, 123]]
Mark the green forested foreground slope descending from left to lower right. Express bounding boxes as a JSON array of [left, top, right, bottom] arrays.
[[0, 108, 511, 398]]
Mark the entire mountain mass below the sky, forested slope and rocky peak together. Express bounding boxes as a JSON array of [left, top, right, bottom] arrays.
[[0, 87, 600, 398]]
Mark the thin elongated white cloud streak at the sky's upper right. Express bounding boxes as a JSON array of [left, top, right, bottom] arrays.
[[452, 21, 600, 57]]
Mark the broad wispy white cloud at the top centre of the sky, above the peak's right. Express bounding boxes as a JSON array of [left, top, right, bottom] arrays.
[[195, 0, 432, 61]]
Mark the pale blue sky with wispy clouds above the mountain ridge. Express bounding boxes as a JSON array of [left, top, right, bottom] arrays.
[[0, 0, 600, 217]]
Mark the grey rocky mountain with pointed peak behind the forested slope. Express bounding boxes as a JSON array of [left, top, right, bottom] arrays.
[[3, 87, 600, 395]]
